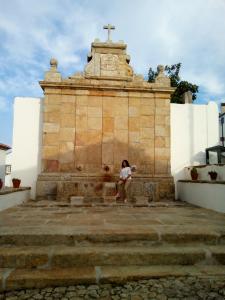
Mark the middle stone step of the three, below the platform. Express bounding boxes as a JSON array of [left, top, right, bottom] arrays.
[[0, 245, 225, 269]]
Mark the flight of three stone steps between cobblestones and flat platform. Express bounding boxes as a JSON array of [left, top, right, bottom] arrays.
[[0, 227, 225, 290]]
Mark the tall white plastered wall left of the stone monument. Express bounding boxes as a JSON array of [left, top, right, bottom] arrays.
[[12, 97, 42, 199]]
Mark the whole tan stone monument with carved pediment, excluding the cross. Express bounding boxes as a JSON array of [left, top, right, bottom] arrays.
[[37, 41, 173, 201]]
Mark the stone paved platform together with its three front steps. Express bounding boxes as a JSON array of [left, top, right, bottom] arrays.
[[0, 201, 225, 290]]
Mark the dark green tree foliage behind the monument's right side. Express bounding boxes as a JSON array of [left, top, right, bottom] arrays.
[[148, 63, 198, 103]]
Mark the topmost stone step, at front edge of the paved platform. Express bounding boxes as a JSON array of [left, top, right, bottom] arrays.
[[0, 224, 221, 246]]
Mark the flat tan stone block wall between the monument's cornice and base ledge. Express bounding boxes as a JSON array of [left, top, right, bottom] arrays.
[[42, 88, 170, 176]]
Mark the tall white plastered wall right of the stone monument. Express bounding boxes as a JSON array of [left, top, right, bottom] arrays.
[[171, 102, 219, 198]]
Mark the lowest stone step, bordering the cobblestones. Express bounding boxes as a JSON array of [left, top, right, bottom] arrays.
[[0, 265, 225, 292]]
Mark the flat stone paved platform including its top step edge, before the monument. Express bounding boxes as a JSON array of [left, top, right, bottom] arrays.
[[0, 201, 225, 245]]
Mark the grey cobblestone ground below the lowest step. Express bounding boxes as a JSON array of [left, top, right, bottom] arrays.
[[0, 277, 225, 300]]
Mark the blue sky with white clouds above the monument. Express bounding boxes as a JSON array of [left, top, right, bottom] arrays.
[[0, 0, 225, 145]]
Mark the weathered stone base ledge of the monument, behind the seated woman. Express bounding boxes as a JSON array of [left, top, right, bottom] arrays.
[[37, 173, 174, 202]]
